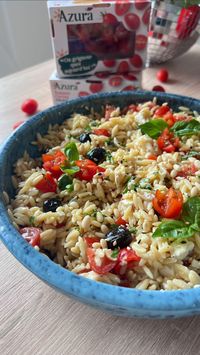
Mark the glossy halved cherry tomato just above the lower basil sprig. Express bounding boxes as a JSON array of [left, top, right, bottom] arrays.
[[152, 187, 183, 218]]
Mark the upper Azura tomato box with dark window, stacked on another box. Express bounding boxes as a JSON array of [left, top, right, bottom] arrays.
[[48, 0, 151, 77]]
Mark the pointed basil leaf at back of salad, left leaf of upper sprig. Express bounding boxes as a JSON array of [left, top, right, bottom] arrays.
[[139, 119, 168, 139]]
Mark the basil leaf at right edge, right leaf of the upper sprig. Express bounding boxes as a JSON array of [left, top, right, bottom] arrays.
[[171, 120, 200, 137]]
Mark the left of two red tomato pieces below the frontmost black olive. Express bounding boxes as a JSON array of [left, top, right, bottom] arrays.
[[87, 248, 117, 275]]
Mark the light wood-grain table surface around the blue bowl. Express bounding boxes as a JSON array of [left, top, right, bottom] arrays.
[[0, 46, 200, 355]]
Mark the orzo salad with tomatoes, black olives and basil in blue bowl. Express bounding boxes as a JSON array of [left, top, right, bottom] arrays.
[[8, 99, 200, 290]]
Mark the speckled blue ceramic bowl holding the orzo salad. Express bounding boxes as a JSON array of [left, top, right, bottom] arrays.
[[0, 91, 200, 318]]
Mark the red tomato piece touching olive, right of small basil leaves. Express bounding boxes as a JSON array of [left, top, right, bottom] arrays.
[[75, 159, 105, 181]]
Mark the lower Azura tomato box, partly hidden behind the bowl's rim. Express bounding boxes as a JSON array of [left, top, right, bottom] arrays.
[[50, 72, 141, 104]]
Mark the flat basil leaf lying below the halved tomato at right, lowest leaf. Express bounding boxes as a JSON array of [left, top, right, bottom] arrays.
[[152, 220, 195, 239]]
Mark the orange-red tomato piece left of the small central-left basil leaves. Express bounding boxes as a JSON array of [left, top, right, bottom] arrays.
[[42, 151, 67, 179]]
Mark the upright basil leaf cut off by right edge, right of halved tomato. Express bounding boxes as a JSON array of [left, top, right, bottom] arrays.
[[181, 196, 200, 230]]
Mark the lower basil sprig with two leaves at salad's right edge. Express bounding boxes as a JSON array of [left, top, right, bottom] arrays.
[[153, 197, 200, 239]]
